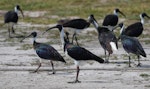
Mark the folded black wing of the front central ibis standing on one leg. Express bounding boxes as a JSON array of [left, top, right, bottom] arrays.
[[67, 46, 104, 63]]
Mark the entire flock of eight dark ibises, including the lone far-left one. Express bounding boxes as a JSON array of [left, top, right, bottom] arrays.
[[4, 5, 150, 83]]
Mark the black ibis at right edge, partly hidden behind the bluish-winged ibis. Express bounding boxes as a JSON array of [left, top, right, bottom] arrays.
[[121, 13, 150, 37]]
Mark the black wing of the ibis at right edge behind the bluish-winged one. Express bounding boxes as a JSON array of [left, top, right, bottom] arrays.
[[125, 22, 143, 37]]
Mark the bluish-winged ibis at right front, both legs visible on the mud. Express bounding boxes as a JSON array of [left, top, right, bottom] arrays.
[[119, 23, 146, 67]]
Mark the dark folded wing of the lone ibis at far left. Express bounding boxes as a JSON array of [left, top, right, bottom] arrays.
[[4, 11, 18, 23]]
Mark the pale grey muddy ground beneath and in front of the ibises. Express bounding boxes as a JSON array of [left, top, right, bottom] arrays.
[[0, 11, 150, 89]]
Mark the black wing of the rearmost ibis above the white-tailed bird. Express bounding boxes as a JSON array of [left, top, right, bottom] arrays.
[[102, 14, 118, 26]]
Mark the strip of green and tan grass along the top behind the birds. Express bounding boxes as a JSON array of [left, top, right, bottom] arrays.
[[0, 0, 150, 24]]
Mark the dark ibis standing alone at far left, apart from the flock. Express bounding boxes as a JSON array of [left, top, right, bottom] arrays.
[[4, 5, 24, 37]]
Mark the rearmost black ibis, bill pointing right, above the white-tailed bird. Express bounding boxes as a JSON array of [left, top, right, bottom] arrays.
[[102, 8, 125, 28]]
